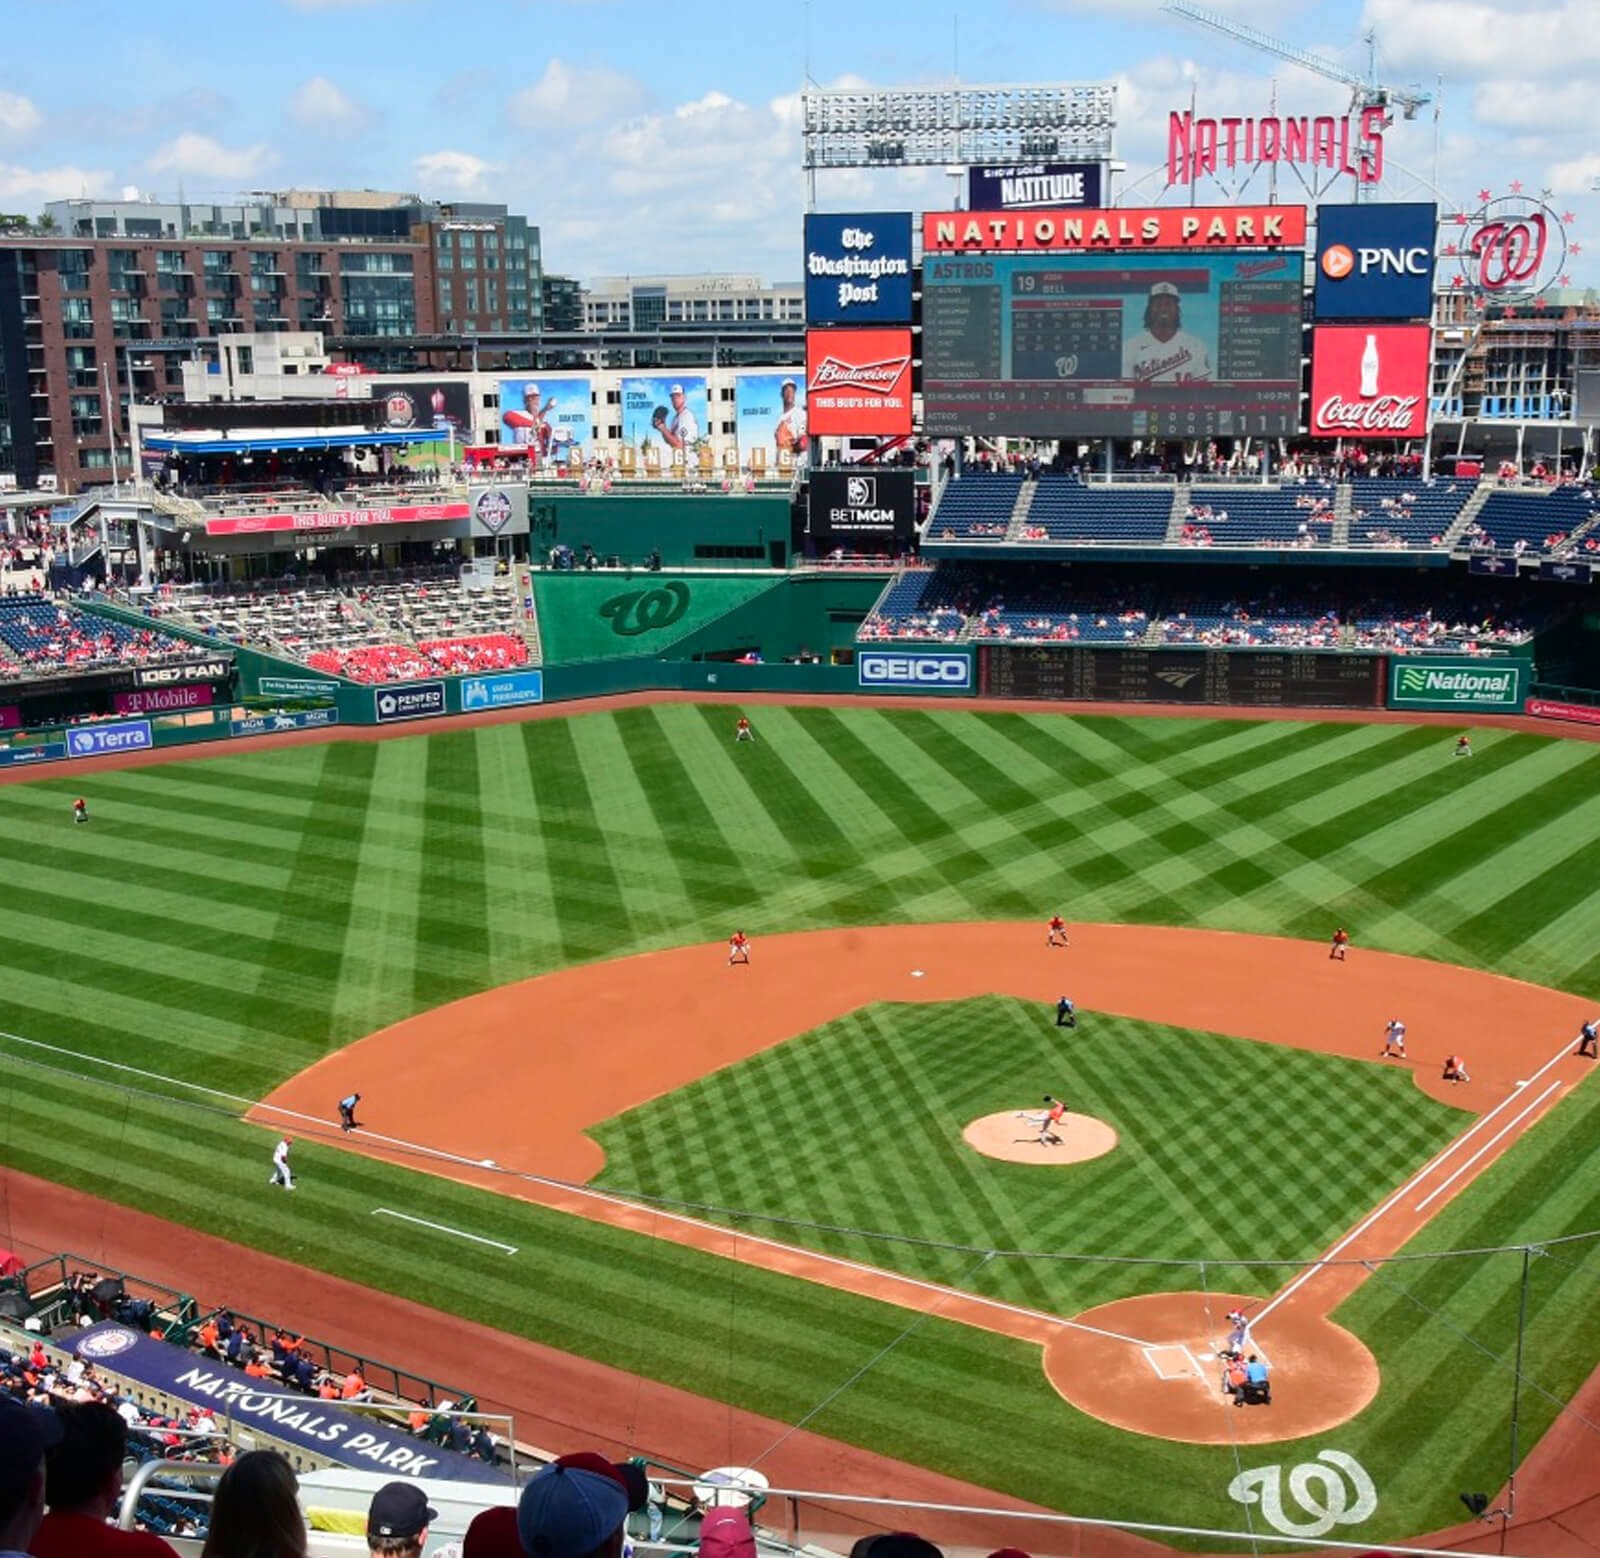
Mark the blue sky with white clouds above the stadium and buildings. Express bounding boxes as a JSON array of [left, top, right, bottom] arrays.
[[0, 0, 1600, 285]]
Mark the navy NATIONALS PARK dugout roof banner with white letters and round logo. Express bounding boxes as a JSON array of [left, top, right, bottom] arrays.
[[69, 1321, 506, 1483]]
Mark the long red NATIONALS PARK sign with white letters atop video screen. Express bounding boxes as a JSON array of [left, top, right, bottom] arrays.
[[922, 206, 1306, 254]]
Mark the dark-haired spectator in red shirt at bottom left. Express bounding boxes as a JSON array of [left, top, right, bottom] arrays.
[[32, 1401, 173, 1558]]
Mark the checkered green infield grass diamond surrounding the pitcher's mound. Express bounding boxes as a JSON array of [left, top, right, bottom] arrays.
[[594, 997, 1469, 1315]]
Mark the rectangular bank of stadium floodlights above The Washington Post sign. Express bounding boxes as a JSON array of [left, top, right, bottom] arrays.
[[800, 82, 1117, 173]]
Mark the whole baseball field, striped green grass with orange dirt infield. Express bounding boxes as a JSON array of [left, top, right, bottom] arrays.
[[0, 702, 1600, 1545]]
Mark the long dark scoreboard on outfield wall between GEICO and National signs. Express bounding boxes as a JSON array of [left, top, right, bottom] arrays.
[[978, 645, 1384, 709]]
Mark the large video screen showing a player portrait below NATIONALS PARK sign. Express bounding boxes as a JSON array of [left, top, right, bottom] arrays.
[[922, 250, 1304, 438]]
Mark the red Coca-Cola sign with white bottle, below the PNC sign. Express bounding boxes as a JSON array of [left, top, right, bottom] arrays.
[[1310, 325, 1432, 441]]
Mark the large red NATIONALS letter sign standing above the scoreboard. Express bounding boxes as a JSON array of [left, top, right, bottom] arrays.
[[1166, 109, 1384, 184]]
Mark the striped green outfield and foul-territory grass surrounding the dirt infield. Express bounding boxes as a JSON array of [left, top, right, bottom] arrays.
[[0, 705, 1600, 1540]]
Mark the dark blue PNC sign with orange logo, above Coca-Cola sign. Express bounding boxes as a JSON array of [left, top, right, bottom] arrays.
[[1314, 203, 1438, 320]]
